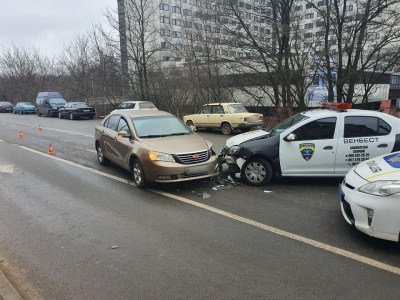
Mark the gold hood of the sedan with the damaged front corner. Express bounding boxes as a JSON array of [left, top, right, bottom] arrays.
[[141, 134, 212, 154]]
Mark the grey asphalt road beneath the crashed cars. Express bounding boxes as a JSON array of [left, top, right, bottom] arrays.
[[0, 114, 400, 299]]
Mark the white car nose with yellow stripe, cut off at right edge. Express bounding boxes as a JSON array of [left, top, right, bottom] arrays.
[[339, 152, 400, 242]]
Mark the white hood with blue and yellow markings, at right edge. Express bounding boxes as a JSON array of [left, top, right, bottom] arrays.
[[354, 152, 400, 181]]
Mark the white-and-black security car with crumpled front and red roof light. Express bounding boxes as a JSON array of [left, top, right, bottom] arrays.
[[219, 103, 400, 186]]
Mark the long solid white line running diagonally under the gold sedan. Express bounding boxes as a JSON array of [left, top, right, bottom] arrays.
[[20, 146, 400, 275]]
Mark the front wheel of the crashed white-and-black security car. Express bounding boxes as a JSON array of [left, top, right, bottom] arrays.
[[240, 157, 272, 186]]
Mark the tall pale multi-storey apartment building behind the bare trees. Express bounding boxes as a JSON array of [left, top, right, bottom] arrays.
[[118, 0, 400, 101]]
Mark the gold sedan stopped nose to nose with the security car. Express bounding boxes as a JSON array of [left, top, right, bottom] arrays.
[[95, 110, 217, 188]]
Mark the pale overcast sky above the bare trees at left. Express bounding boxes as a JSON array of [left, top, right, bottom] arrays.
[[0, 0, 117, 56]]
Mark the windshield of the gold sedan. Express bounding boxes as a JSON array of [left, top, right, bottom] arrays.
[[132, 116, 193, 138]]
